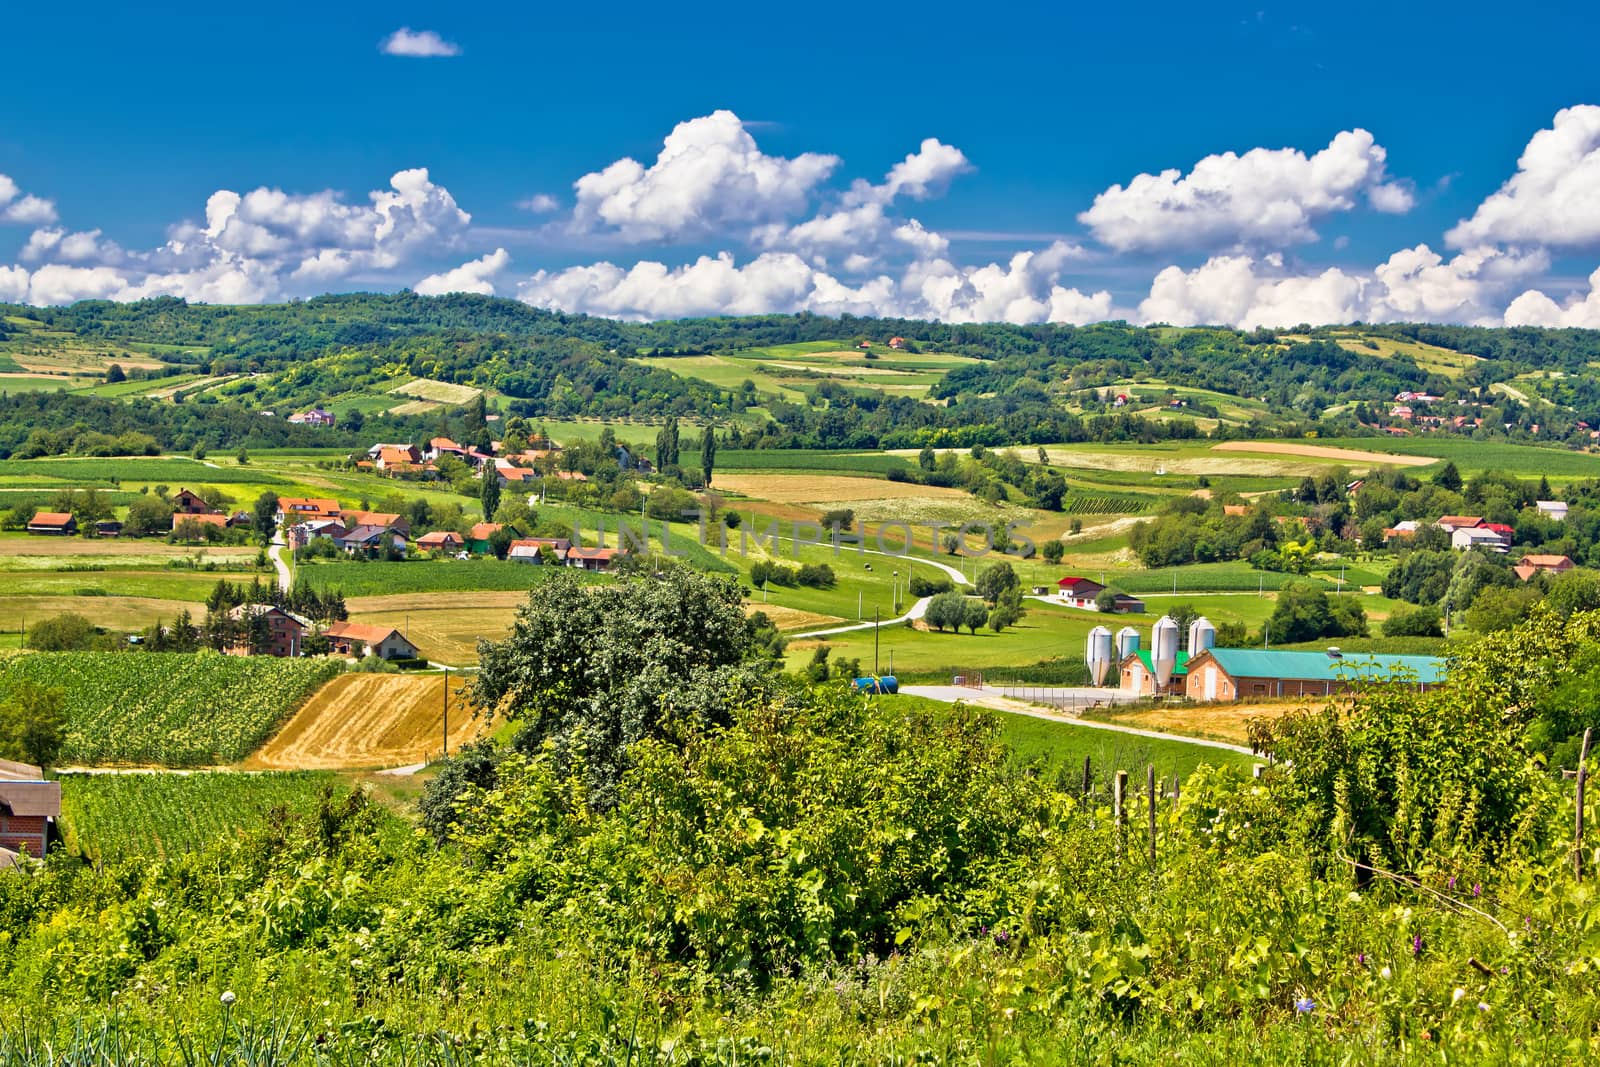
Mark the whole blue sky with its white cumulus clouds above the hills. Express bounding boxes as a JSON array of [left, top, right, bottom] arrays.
[[0, 3, 1600, 326]]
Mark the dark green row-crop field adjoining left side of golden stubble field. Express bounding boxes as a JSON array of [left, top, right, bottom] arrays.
[[0, 653, 344, 766]]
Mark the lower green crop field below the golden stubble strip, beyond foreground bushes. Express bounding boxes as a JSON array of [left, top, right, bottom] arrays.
[[61, 771, 339, 862]]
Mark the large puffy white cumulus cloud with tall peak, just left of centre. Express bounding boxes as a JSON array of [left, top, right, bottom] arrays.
[[573, 110, 838, 242]]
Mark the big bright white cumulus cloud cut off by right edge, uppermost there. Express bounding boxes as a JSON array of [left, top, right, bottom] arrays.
[[1445, 104, 1600, 248]]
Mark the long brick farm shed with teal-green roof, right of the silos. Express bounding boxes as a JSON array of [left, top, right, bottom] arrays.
[[1186, 648, 1445, 701]]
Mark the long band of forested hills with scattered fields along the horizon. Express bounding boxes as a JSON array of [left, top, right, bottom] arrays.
[[0, 293, 1600, 454]]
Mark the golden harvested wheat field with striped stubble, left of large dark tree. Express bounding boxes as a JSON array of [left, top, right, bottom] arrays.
[[243, 673, 486, 771]]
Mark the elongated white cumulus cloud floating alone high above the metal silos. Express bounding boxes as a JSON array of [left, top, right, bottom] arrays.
[[1078, 130, 1413, 251]]
